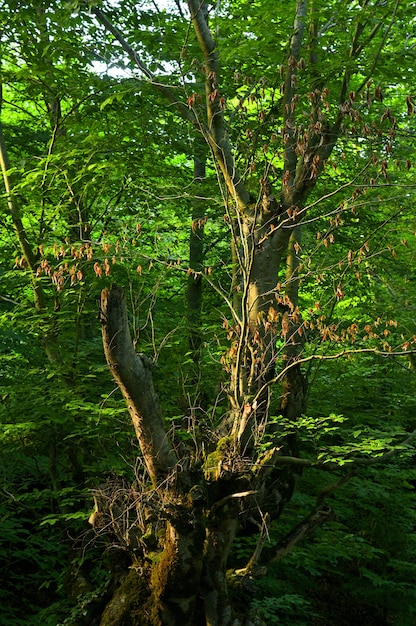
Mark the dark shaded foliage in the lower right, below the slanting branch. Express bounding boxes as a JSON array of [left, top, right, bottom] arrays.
[[247, 456, 416, 625]]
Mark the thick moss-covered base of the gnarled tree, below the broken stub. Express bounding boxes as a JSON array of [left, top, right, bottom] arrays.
[[96, 477, 254, 626]]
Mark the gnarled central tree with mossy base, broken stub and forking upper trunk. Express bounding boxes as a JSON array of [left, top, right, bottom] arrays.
[[88, 0, 416, 625]]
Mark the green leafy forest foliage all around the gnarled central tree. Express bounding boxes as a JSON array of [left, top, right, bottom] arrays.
[[0, 0, 416, 626]]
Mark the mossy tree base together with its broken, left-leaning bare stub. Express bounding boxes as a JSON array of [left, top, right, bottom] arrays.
[[98, 286, 289, 626]]
